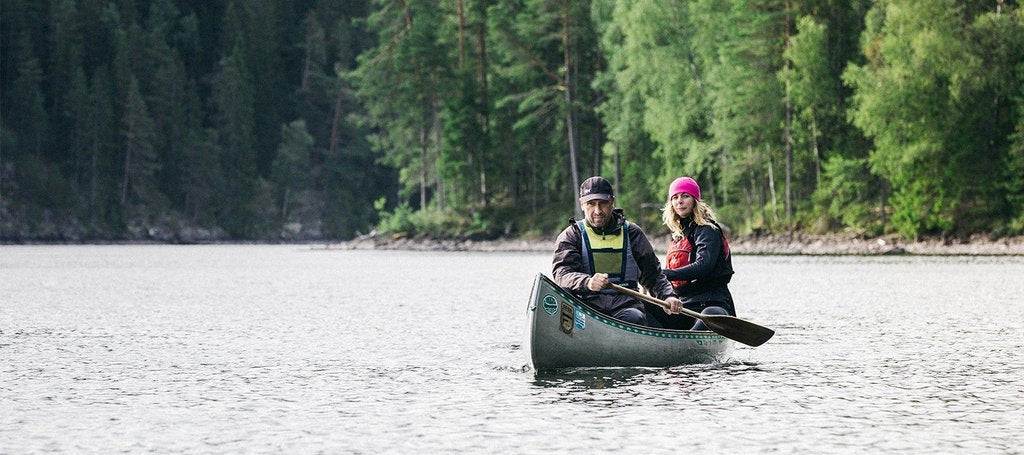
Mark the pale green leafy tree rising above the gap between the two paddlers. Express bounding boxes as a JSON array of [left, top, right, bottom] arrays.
[[595, 1, 718, 224]]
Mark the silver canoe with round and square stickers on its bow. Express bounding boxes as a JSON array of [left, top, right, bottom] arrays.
[[527, 274, 732, 370]]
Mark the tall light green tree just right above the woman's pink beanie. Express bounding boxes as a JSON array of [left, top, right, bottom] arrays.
[[693, 0, 785, 228]]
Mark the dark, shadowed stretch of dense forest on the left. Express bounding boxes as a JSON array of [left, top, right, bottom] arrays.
[[0, 0, 387, 239]]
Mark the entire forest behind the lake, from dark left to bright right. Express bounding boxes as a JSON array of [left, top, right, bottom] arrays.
[[0, 0, 1024, 241]]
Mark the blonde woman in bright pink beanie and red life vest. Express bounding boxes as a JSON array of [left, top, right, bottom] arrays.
[[646, 177, 736, 330]]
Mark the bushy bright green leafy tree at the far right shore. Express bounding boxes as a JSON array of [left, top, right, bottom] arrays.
[[846, 0, 1022, 237]]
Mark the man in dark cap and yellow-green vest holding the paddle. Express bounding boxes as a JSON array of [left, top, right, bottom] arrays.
[[552, 176, 683, 325]]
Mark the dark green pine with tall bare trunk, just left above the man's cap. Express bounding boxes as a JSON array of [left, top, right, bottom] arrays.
[[487, 1, 602, 223]]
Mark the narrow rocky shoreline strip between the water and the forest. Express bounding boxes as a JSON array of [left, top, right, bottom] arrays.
[[326, 230, 1024, 256]]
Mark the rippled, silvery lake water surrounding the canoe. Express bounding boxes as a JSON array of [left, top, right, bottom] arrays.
[[0, 245, 1024, 454]]
